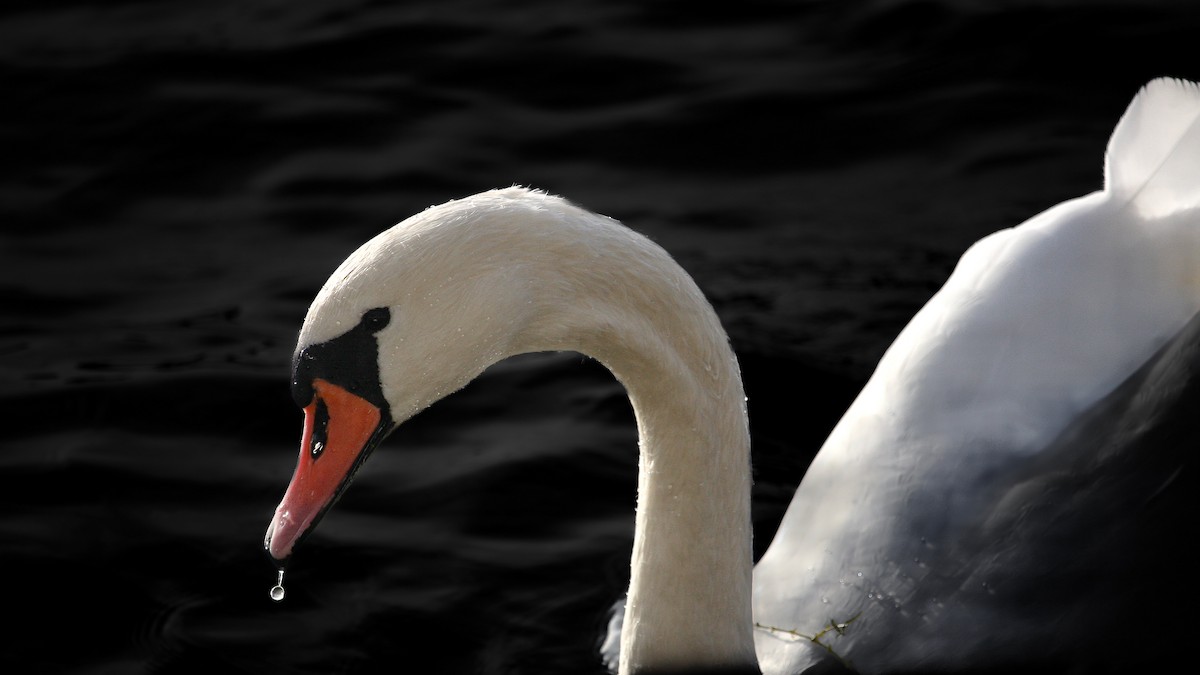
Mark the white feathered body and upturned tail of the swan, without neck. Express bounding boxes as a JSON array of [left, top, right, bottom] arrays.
[[755, 79, 1200, 673]]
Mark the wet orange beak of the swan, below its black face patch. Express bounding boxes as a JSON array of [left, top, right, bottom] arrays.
[[264, 378, 389, 559]]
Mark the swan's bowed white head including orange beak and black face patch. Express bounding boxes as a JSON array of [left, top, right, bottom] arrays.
[[265, 189, 606, 565]]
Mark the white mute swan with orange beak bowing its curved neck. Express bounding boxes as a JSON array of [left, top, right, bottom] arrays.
[[265, 79, 1200, 674]]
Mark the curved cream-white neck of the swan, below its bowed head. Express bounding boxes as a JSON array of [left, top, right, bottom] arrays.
[[520, 229, 757, 674]]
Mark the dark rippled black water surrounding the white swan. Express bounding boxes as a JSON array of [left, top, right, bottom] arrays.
[[0, 0, 1200, 674]]
